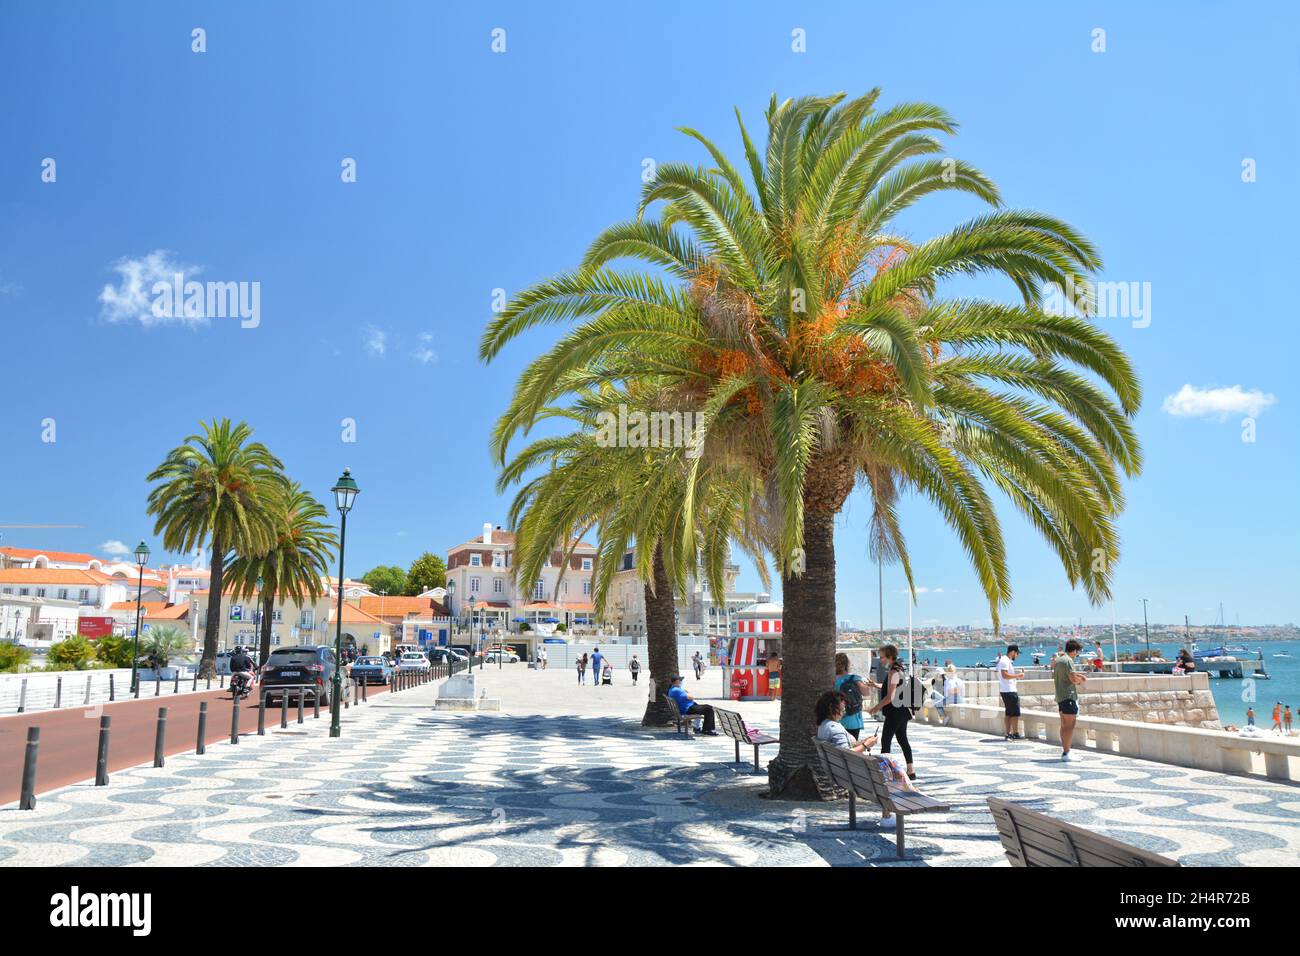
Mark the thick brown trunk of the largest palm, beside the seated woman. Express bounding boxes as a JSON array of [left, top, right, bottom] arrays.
[[767, 458, 854, 800]]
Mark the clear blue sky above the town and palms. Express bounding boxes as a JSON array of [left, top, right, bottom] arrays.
[[0, 3, 1300, 626]]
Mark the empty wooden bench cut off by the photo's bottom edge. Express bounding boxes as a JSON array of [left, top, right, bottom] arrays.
[[988, 797, 1179, 866]]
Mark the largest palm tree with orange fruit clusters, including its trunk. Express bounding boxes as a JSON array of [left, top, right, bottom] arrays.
[[481, 91, 1140, 796]]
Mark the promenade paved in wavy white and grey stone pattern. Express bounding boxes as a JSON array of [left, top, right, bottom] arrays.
[[0, 665, 1300, 866]]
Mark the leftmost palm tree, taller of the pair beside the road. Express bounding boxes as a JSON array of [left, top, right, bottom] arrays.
[[148, 419, 283, 678]]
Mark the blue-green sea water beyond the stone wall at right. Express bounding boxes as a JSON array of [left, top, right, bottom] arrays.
[[917, 641, 1300, 730]]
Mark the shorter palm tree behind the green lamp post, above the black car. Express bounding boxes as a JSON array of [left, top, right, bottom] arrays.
[[228, 481, 338, 662]]
